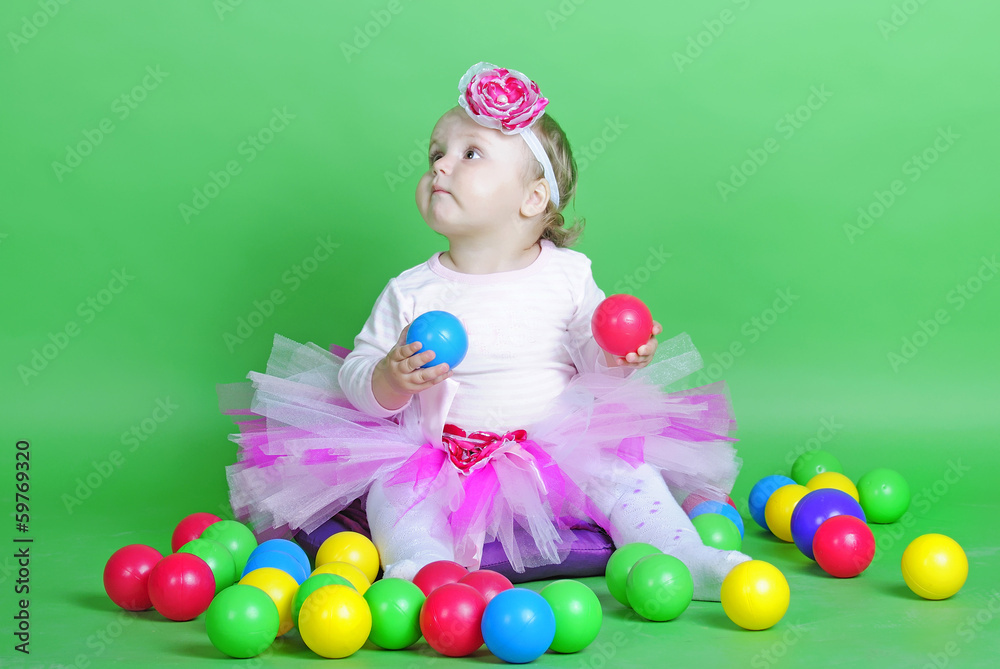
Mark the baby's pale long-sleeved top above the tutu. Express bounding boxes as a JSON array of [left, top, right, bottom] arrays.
[[339, 240, 627, 438]]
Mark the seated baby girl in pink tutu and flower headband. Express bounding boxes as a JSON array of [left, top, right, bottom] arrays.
[[221, 63, 750, 601]]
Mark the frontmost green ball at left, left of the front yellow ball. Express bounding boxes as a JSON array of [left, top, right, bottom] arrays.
[[205, 584, 279, 658]]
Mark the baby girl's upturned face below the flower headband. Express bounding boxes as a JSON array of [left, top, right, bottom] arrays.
[[416, 108, 534, 244]]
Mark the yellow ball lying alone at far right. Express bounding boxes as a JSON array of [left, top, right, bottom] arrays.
[[902, 534, 969, 599]]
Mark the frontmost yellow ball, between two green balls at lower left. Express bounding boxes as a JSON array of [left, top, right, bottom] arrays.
[[299, 585, 372, 658]]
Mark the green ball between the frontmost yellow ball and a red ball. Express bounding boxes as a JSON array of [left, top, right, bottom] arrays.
[[364, 578, 427, 650]]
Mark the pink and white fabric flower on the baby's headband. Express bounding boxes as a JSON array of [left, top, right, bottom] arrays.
[[458, 63, 549, 135]]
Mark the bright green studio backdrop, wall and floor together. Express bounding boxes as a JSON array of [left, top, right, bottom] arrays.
[[0, 0, 1000, 668]]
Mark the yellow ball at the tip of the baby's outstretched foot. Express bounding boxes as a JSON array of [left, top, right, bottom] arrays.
[[722, 560, 789, 630]]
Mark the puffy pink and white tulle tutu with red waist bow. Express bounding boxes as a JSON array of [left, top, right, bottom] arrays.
[[218, 334, 740, 571]]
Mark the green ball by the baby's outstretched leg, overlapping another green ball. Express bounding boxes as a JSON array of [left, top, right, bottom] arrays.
[[625, 554, 694, 622]]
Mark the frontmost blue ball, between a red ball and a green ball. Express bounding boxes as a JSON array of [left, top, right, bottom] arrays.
[[482, 588, 556, 664]]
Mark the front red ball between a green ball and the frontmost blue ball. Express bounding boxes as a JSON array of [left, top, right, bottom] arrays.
[[420, 583, 486, 657]]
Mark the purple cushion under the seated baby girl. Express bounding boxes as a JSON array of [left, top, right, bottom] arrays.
[[295, 500, 615, 583]]
